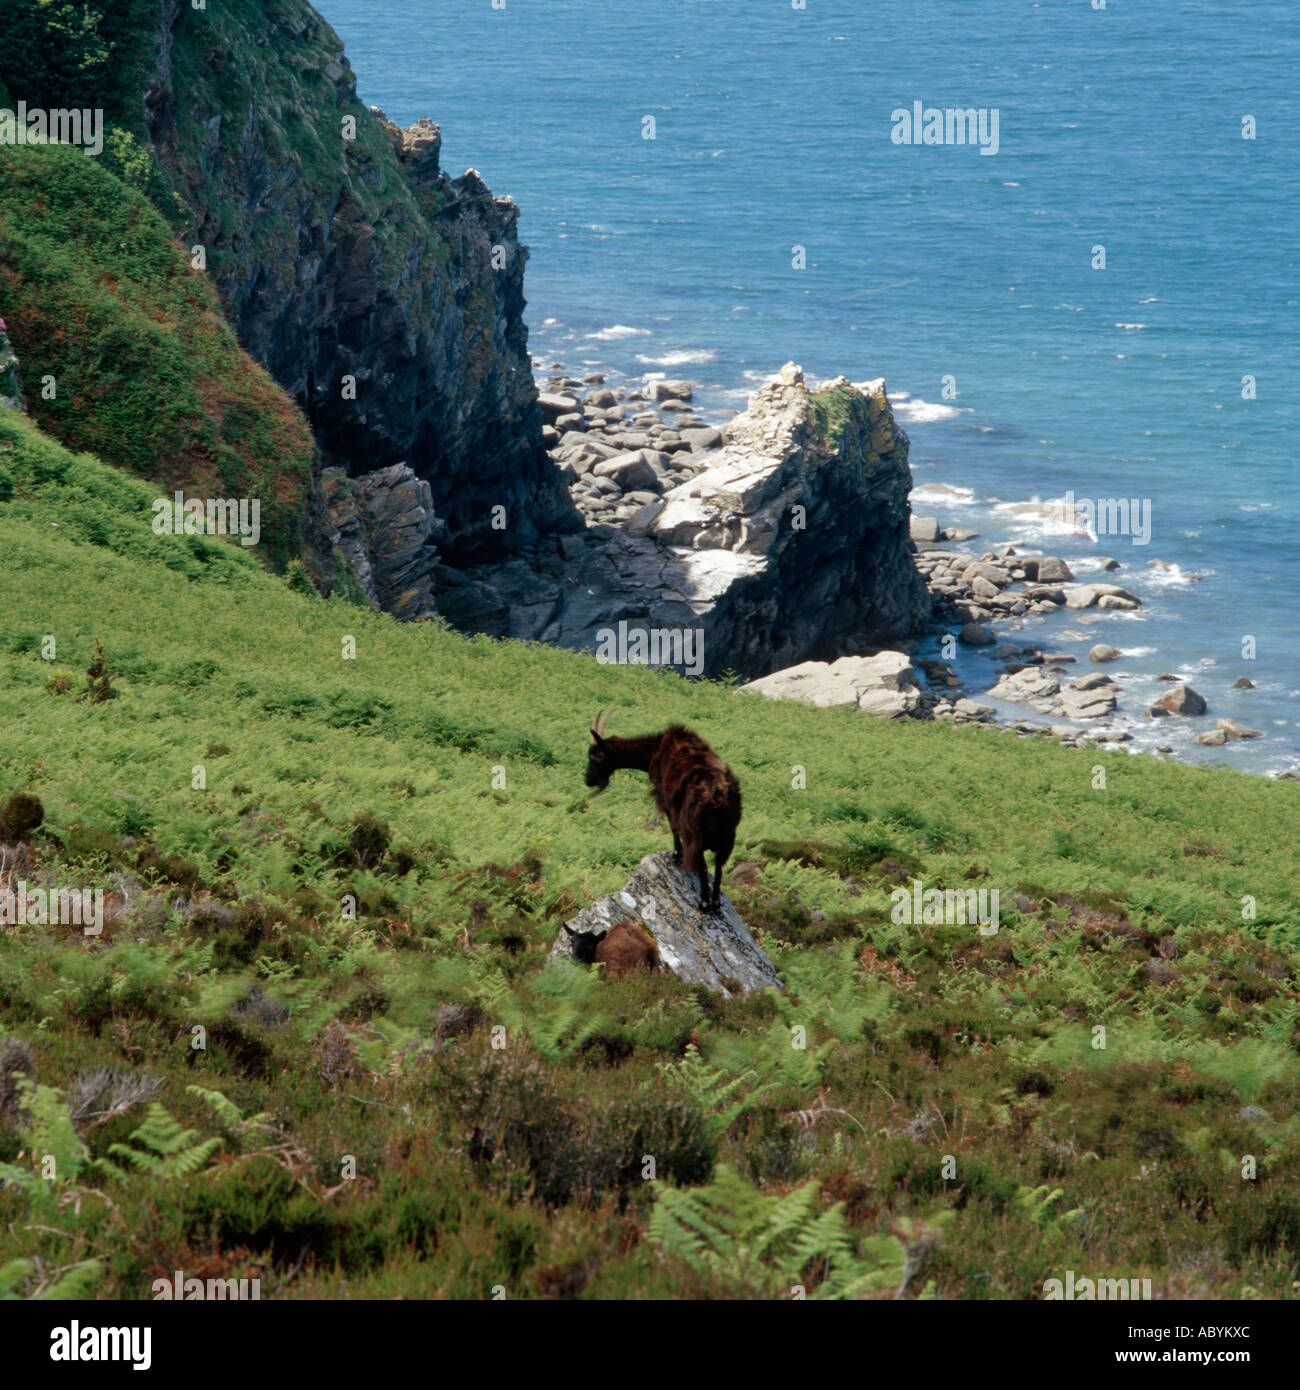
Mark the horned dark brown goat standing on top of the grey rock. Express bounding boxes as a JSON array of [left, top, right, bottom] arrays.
[[587, 710, 740, 912]]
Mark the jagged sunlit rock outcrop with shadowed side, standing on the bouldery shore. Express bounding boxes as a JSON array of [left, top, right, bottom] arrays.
[[453, 366, 930, 677]]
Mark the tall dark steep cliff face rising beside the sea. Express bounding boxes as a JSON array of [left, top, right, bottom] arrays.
[[143, 0, 580, 567]]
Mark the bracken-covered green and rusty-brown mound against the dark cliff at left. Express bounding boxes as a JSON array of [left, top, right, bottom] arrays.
[[0, 146, 314, 566]]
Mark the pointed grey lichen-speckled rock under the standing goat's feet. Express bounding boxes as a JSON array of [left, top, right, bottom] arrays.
[[551, 849, 781, 995]]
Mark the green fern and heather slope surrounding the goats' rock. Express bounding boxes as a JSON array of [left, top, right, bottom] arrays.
[[0, 414, 1300, 1298]]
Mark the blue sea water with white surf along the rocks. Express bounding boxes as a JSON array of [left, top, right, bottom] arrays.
[[317, 0, 1300, 771]]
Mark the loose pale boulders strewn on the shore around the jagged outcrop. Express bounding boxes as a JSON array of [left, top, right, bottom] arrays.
[[522, 353, 1260, 753]]
